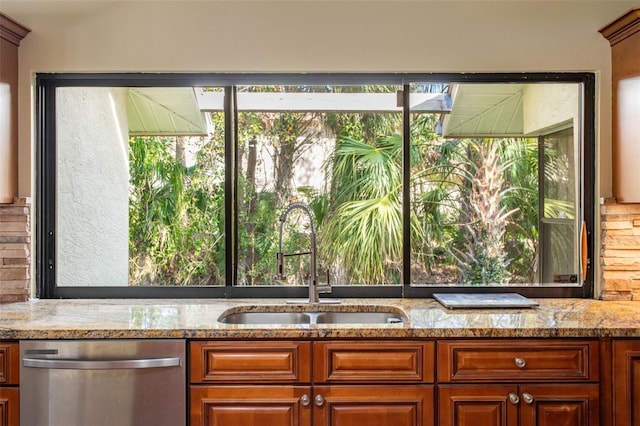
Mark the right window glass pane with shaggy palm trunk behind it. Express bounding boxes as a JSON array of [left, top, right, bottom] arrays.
[[410, 83, 581, 286]]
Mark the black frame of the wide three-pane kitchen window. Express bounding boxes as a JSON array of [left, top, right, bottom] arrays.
[[35, 72, 596, 299]]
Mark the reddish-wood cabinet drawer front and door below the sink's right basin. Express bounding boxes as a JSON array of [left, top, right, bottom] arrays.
[[312, 340, 435, 426]]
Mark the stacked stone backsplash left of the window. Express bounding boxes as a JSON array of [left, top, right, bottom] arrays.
[[0, 198, 31, 303]]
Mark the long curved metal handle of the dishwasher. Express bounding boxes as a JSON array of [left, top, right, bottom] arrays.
[[22, 357, 182, 370]]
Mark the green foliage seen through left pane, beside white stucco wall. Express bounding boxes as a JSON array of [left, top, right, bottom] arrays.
[[129, 131, 224, 285]]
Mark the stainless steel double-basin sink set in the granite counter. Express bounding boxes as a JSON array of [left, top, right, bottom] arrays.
[[218, 305, 407, 325]]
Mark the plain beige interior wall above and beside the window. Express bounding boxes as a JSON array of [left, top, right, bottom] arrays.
[[0, 0, 637, 200]]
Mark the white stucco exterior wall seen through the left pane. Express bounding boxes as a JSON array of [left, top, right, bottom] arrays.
[[56, 87, 129, 286]]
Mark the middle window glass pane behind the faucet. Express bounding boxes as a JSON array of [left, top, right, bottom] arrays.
[[237, 86, 402, 285]]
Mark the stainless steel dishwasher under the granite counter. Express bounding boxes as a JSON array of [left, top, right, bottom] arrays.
[[20, 339, 187, 426]]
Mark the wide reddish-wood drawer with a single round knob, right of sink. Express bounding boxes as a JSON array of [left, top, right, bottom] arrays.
[[438, 340, 599, 382]]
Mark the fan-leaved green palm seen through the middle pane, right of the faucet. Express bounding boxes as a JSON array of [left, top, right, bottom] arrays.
[[321, 136, 402, 284]]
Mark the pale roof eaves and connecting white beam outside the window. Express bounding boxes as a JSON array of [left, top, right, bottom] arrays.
[[128, 84, 525, 138]]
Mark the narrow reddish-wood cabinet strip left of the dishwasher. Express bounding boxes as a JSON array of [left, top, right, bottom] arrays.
[[0, 342, 20, 426]]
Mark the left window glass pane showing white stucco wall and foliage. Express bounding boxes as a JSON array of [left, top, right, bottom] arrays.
[[56, 87, 225, 286]]
